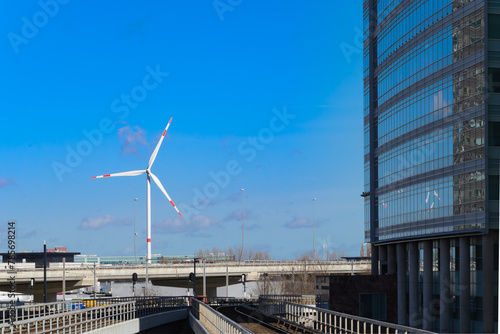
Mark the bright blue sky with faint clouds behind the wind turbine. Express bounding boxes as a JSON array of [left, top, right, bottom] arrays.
[[0, 0, 363, 259]]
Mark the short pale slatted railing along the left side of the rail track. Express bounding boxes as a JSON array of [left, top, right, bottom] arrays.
[[191, 298, 252, 334]]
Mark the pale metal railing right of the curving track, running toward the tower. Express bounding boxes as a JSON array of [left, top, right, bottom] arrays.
[[259, 296, 432, 334]]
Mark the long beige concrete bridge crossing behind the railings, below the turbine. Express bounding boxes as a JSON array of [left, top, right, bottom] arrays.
[[0, 260, 371, 301]]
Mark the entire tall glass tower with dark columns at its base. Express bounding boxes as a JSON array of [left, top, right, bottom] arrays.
[[362, 0, 500, 333]]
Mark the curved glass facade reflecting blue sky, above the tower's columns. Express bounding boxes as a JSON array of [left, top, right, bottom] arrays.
[[364, 0, 488, 243]]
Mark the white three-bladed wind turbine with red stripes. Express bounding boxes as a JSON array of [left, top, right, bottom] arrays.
[[91, 118, 182, 263]]
